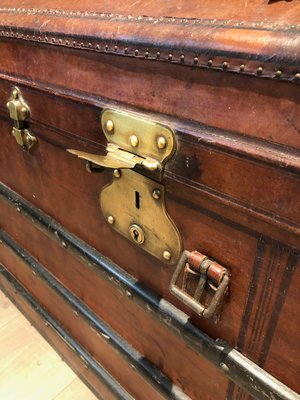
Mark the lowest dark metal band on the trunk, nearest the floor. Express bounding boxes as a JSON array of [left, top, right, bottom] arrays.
[[0, 266, 133, 400]]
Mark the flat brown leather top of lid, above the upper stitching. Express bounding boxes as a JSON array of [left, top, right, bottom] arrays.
[[0, 0, 300, 23]]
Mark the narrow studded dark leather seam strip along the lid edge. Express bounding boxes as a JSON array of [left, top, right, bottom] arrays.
[[0, 26, 300, 83]]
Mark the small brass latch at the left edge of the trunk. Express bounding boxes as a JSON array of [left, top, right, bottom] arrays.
[[6, 86, 37, 151]]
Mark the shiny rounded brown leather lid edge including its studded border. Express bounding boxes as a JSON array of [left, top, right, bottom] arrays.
[[0, 3, 300, 81]]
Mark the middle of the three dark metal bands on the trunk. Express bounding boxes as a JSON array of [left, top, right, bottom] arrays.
[[0, 229, 190, 400]]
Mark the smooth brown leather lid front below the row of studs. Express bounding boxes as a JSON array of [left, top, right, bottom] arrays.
[[0, 41, 300, 150]]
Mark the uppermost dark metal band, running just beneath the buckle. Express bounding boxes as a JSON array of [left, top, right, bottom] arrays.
[[0, 184, 300, 400]]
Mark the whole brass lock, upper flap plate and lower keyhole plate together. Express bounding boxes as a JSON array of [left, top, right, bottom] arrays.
[[67, 109, 181, 264]]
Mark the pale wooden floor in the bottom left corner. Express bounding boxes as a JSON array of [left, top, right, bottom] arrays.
[[0, 291, 96, 400]]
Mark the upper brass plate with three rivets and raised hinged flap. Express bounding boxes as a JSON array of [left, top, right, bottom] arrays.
[[67, 110, 175, 181]]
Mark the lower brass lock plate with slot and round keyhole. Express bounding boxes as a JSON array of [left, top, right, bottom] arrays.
[[100, 169, 182, 265]]
